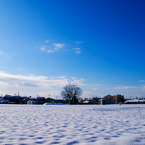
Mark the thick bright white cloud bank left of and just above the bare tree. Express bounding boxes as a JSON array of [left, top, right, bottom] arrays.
[[0, 72, 84, 97]]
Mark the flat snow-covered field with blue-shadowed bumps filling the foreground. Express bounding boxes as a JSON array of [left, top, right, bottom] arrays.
[[0, 104, 145, 145]]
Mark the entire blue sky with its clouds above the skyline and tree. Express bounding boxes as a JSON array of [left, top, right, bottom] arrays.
[[0, 0, 145, 98]]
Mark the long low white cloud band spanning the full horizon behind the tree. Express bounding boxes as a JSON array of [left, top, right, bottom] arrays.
[[0, 71, 145, 97]]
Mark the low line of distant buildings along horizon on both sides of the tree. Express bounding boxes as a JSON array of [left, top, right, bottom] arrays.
[[0, 94, 145, 105]]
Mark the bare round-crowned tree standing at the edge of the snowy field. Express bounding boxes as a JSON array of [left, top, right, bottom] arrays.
[[61, 84, 82, 104]]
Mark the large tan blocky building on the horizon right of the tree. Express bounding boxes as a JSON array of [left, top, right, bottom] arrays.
[[104, 94, 124, 104]]
